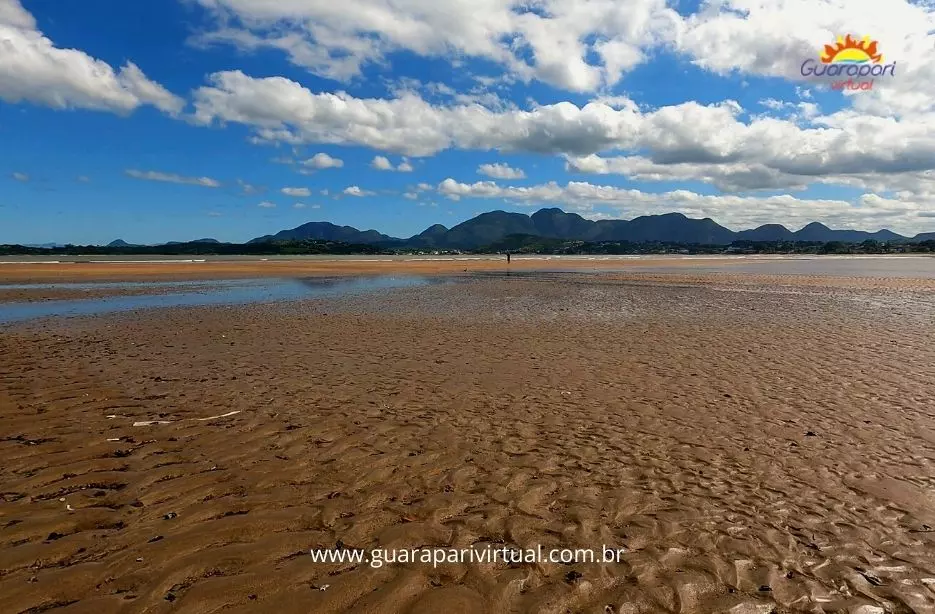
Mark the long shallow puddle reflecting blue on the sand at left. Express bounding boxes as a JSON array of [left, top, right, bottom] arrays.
[[0, 275, 444, 324]]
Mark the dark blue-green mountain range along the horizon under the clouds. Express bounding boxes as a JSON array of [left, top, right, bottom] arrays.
[[243, 208, 935, 249]]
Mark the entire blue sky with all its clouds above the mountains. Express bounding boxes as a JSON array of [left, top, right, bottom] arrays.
[[0, 0, 935, 243]]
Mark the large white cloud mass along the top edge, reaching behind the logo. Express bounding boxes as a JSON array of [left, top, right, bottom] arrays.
[[186, 0, 935, 116]]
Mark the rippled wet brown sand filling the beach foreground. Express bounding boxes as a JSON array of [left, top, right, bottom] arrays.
[[0, 276, 935, 614]]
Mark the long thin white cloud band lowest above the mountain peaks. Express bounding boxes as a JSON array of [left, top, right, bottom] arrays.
[[437, 178, 925, 235]]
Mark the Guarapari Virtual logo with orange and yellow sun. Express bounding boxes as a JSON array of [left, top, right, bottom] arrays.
[[800, 34, 896, 91]]
